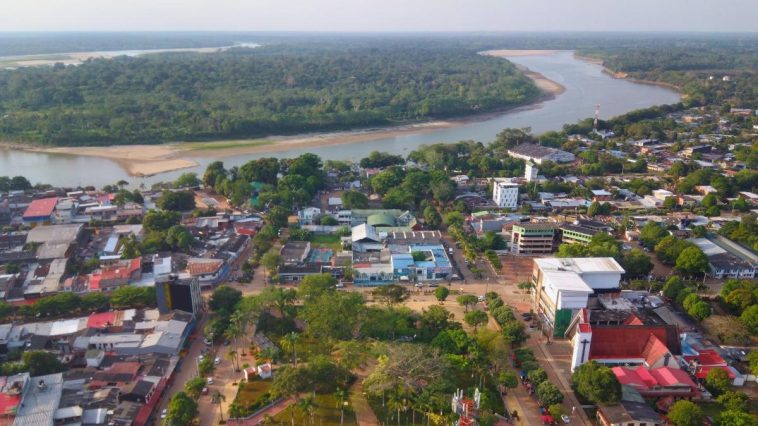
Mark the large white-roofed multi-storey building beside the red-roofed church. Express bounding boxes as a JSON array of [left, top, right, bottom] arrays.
[[532, 257, 624, 337]]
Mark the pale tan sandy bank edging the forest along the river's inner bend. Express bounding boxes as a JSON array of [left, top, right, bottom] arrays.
[[1, 50, 566, 176]]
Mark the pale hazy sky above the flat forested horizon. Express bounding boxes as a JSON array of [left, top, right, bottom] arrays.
[[0, 0, 758, 32]]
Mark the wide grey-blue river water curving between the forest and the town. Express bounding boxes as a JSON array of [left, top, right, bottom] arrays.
[[0, 51, 679, 186]]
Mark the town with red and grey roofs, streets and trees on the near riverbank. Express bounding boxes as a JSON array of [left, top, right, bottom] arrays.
[[0, 100, 758, 426]]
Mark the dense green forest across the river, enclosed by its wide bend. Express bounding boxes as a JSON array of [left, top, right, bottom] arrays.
[[0, 40, 540, 145]]
